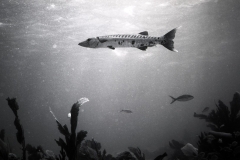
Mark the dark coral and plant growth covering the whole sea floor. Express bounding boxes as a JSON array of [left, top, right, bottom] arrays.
[[0, 92, 240, 160]]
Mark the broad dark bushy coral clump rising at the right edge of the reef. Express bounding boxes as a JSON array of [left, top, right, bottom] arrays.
[[194, 92, 240, 160]]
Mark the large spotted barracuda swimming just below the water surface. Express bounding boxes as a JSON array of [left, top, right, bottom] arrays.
[[78, 27, 179, 52]]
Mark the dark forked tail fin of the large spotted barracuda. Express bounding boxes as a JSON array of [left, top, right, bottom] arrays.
[[161, 26, 181, 52]]
